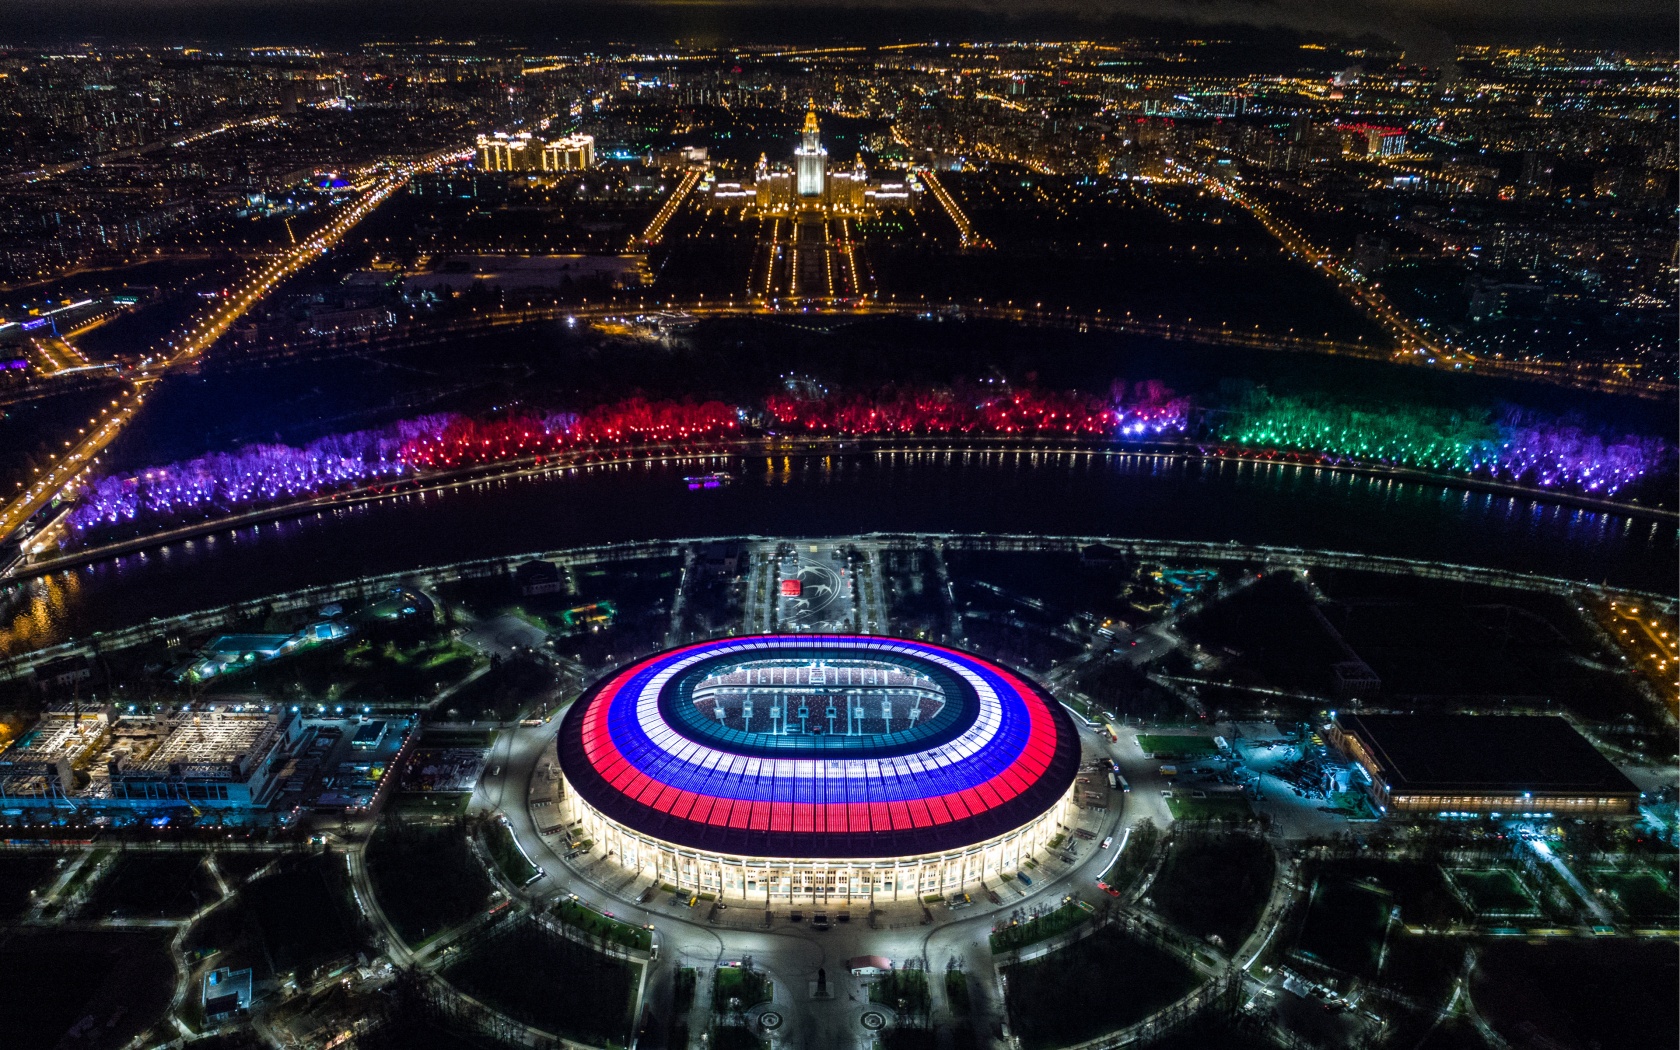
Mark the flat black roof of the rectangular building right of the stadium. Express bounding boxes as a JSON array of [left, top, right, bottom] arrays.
[[1336, 714, 1638, 795]]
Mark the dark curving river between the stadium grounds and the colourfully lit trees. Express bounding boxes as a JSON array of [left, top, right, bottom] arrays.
[[0, 450, 1680, 652]]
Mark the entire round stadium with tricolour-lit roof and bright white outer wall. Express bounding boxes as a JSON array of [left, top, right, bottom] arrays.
[[558, 635, 1079, 900]]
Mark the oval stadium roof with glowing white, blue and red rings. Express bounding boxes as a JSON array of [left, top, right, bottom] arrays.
[[558, 635, 1079, 858]]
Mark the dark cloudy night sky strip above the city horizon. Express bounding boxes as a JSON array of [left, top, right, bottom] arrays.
[[0, 0, 1680, 49]]
